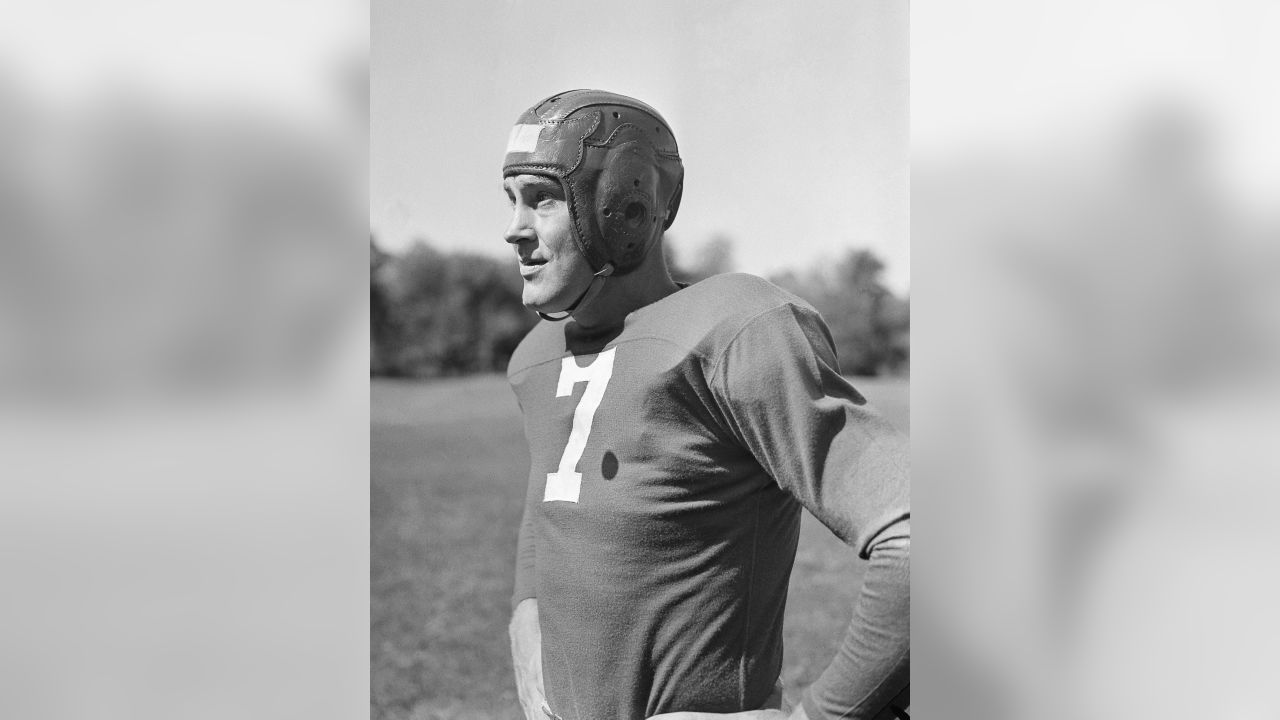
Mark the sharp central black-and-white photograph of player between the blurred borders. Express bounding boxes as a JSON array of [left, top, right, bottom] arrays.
[[370, 0, 910, 720]]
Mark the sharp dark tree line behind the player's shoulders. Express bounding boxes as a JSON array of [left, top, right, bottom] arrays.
[[369, 237, 910, 378]]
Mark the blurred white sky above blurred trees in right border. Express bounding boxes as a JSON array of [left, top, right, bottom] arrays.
[[911, 0, 1280, 214]]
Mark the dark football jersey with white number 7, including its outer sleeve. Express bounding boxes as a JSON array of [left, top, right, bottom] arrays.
[[508, 274, 909, 720]]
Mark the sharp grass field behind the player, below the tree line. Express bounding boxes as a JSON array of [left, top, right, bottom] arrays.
[[370, 375, 909, 720]]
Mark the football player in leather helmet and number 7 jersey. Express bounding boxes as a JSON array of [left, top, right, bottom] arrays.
[[503, 90, 910, 720]]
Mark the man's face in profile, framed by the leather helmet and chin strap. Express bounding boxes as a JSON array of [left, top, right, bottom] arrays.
[[502, 176, 593, 313]]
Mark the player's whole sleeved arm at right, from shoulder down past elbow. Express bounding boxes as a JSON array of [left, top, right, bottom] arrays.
[[712, 305, 910, 720]]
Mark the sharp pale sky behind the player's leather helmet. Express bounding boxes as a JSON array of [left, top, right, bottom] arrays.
[[370, 0, 910, 292]]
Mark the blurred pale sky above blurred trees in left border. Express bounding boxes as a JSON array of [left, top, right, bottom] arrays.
[[0, 0, 367, 123]]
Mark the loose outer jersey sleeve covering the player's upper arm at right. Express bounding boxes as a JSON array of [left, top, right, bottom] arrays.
[[708, 304, 910, 559]]
